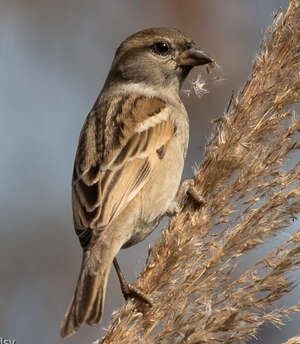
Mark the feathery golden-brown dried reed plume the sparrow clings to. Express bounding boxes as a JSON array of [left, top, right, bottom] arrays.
[[100, 0, 300, 344]]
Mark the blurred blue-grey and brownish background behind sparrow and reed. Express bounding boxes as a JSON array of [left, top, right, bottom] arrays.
[[0, 0, 299, 344]]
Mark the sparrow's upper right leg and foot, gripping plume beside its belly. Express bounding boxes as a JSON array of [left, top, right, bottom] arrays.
[[167, 178, 205, 216]]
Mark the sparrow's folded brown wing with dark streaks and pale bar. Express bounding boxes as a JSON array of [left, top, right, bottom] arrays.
[[73, 94, 176, 243]]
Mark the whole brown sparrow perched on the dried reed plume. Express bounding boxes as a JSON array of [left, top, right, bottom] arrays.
[[61, 28, 213, 337]]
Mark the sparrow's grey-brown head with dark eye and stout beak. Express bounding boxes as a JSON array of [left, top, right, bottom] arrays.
[[107, 28, 212, 89]]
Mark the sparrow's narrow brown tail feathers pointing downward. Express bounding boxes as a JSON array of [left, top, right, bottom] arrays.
[[60, 243, 114, 337]]
